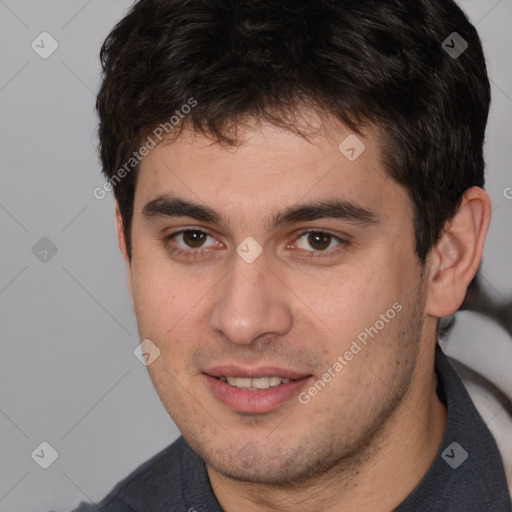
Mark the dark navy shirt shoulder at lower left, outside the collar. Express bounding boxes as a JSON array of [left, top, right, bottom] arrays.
[[69, 436, 185, 512]]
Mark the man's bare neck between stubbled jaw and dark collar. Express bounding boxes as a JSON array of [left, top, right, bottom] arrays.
[[207, 347, 446, 512]]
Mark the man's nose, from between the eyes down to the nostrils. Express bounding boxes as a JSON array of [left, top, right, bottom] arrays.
[[210, 253, 293, 345]]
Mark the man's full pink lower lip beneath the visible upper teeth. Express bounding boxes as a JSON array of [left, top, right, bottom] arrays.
[[205, 375, 312, 414]]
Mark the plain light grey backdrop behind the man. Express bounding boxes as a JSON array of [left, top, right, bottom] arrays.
[[0, 0, 512, 512]]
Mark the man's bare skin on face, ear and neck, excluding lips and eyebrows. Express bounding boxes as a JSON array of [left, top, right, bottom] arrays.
[[116, 113, 491, 512]]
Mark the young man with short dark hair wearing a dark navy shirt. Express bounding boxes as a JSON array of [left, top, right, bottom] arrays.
[[74, 0, 511, 512]]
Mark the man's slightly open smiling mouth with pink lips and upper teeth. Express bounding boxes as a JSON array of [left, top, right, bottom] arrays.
[[203, 366, 314, 414]]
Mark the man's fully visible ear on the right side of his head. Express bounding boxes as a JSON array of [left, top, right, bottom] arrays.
[[425, 187, 491, 318]]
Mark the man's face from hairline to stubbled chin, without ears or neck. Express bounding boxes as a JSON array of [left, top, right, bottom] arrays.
[[125, 116, 432, 483]]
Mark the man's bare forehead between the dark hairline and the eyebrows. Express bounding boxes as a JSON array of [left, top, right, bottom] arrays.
[[135, 119, 411, 227]]
